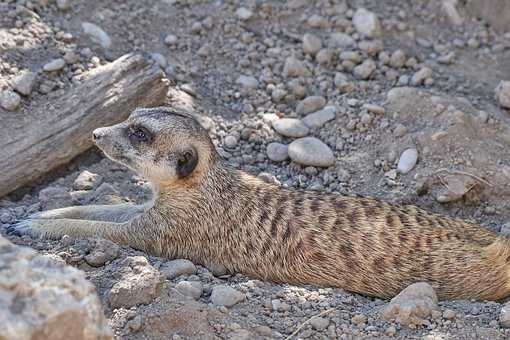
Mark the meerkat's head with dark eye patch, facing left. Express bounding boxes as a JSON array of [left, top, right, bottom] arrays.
[[92, 107, 217, 186]]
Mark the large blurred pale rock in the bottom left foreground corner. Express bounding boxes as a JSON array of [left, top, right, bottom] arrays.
[[0, 236, 112, 340]]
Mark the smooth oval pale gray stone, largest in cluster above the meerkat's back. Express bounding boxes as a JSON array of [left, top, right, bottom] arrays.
[[289, 137, 335, 167]]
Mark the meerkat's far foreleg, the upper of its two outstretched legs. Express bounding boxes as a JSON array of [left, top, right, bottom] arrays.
[[28, 203, 147, 222]]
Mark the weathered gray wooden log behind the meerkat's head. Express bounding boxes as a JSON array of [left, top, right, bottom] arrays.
[[0, 54, 168, 197]]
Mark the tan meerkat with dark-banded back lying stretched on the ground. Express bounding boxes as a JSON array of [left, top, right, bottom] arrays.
[[10, 107, 510, 300]]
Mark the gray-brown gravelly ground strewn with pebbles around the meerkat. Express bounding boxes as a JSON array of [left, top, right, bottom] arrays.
[[0, 0, 510, 339]]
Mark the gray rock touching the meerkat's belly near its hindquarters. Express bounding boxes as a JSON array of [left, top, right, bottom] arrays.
[[382, 282, 439, 326]]
